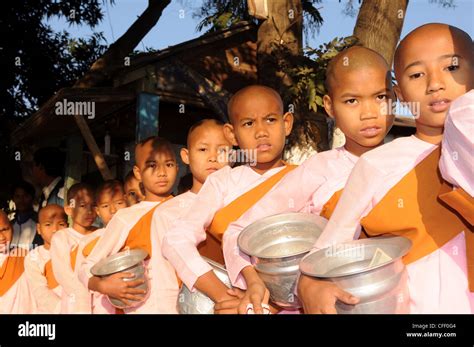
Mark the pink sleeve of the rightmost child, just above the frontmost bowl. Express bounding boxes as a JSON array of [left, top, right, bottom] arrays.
[[314, 156, 384, 249]]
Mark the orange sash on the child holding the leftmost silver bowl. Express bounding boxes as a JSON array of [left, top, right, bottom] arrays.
[[121, 195, 173, 259]]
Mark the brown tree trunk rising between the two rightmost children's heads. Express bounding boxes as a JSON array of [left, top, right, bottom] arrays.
[[354, 0, 408, 66]]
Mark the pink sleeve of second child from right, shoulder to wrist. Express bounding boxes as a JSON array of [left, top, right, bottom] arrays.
[[223, 159, 326, 289]]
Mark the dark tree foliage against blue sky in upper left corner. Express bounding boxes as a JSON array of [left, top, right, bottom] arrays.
[[0, 0, 108, 122]]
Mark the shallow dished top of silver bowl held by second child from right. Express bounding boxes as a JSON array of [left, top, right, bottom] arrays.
[[237, 213, 327, 259]]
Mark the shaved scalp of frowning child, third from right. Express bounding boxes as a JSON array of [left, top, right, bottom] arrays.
[[227, 84, 283, 124]]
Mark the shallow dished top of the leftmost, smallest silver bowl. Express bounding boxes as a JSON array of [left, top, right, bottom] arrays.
[[91, 248, 148, 276]]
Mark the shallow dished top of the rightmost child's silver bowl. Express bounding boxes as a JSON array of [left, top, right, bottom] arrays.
[[300, 236, 412, 278]]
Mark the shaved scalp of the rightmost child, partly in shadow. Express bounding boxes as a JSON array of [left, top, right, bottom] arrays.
[[394, 23, 474, 76]]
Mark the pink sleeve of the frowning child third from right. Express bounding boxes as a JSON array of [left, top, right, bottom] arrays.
[[162, 168, 230, 290]]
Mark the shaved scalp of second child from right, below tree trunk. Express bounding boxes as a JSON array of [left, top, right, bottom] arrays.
[[325, 46, 391, 95]]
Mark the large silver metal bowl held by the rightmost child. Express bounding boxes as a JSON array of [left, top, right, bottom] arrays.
[[300, 236, 411, 314]]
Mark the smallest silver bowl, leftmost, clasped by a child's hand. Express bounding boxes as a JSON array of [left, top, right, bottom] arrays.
[[91, 249, 148, 309]]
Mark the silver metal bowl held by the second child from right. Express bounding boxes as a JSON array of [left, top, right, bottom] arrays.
[[238, 213, 327, 309]]
